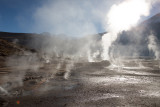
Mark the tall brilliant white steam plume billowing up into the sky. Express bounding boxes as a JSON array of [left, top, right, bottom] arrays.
[[102, 0, 157, 60]]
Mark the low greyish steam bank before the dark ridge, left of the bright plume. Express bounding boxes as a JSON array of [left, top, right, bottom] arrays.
[[36, 34, 102, 62]]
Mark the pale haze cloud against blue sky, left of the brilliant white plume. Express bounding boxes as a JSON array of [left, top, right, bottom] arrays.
[[33, 0, 121, 37]]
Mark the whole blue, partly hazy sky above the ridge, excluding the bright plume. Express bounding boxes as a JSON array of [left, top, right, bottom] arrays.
[[0, 0, 160, 36]]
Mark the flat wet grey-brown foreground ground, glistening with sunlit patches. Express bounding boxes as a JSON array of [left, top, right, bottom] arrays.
[[0, 59, 160, 107]]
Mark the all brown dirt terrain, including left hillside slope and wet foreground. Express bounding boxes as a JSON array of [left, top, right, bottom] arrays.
[[0, 33, 160, 107]]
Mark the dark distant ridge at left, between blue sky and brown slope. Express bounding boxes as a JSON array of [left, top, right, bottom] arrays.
[[0, 32, 49, 50]]
